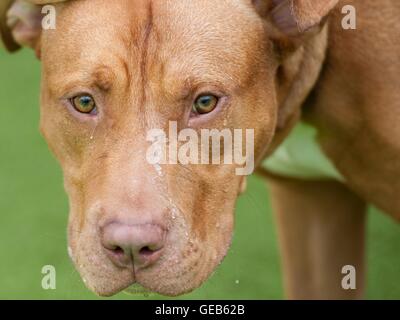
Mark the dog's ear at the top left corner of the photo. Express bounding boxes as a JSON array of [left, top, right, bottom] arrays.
[[0, 0, 43, 56]]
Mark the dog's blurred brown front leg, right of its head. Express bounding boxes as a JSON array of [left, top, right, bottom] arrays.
[[268, 177, 366, 299]]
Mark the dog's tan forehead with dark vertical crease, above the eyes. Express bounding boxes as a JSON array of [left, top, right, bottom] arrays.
[[43, 0, 262, 80]]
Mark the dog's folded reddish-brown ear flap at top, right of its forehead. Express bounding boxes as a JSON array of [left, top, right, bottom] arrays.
[[252, 0, 339, 37]]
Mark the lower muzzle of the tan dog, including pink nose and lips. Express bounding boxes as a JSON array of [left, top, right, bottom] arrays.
[[68, 164, 239, 297]]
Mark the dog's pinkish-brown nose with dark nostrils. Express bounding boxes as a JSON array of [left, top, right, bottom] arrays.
[[102, 221, 166, 268]]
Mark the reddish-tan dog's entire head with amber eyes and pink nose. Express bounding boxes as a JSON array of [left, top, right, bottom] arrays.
[[3, 0, 337, 295]]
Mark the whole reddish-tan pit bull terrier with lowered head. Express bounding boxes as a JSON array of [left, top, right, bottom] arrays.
[[0, 0, 400, 299]]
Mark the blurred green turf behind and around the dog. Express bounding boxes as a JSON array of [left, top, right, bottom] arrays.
[[0, 51, 400, 299]]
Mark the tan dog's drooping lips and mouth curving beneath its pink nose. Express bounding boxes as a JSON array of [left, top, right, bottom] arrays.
[[70, 219, 231, 297]]
